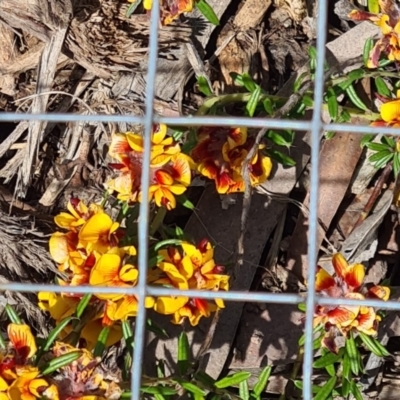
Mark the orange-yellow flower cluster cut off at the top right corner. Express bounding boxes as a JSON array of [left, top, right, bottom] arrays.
[[349, 0, 400, 68]]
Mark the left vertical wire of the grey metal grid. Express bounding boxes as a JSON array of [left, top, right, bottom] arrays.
[[131, 0, 160, 400]]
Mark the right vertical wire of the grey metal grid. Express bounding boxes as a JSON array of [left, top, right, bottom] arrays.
[[303, 0, 328, 400]]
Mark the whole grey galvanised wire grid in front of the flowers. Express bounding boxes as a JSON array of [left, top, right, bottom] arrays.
[[0, 0, 400, 400]]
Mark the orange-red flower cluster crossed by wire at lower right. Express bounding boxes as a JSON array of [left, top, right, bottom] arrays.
[[314, 253, 390, 351]]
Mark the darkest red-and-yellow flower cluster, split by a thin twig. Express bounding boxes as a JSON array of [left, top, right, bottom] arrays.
[[191, 127, 272, 194]]
